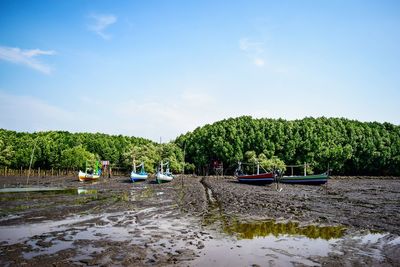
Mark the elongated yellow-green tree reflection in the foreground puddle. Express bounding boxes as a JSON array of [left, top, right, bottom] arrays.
[[223, 219, 346, 240]]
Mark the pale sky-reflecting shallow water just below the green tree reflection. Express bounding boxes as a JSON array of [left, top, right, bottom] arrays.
[[193, 235, 335, 266]]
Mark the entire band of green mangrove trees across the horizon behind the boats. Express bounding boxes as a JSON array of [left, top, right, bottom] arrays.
[[0, 116, 400, 175]]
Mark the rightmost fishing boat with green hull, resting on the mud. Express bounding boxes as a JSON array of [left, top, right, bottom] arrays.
[[278, 163, 329, 185]]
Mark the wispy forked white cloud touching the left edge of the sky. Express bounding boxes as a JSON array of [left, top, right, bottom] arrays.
[[0, 46, 56, 74]]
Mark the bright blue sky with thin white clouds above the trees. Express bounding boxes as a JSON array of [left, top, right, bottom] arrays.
[[0, 0, 400, 142]]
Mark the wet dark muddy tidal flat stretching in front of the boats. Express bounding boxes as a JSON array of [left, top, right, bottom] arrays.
[[0, 176, 400, 266]]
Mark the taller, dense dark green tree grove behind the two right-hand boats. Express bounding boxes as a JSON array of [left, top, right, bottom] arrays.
[[175, 116, 400, 175]]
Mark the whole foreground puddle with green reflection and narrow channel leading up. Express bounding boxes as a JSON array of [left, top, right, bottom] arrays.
[[199, 180, 400, 266]]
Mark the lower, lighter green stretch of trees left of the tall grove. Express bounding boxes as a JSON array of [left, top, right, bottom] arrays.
[[0, 129, 183, 173]]
